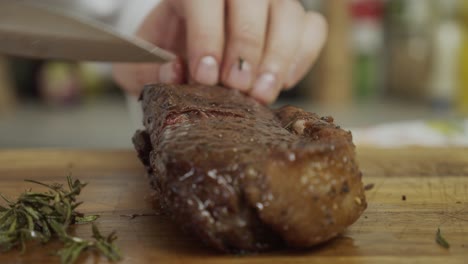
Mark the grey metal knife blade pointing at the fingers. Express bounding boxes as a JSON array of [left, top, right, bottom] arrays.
[[0, 0, 176, 63]]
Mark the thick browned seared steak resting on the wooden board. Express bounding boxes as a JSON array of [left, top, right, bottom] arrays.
[[133, 84, 366, 252]]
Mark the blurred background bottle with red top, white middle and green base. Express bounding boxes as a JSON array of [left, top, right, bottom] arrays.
[[351, 0, 384, 101]]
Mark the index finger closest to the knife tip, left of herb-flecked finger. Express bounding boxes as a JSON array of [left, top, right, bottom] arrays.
[[180, 0, 224, 85]]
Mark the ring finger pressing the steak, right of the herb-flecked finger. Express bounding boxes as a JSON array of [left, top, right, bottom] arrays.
[[250, 0, 305, 103]]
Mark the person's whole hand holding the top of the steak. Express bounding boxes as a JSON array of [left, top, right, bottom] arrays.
[[114, 0, 327, 103]]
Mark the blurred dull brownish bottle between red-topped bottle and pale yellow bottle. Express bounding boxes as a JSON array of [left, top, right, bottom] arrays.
[[385, 0, 432, 101]]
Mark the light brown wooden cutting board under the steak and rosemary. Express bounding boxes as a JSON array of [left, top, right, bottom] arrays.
[[0, 149, 468, 264]]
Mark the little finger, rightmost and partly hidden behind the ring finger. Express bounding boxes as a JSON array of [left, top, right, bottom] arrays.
[[285, 12, 327, 89]]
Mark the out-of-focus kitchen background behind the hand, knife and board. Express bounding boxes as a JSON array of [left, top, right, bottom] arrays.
[[0, 0, 468, 148]]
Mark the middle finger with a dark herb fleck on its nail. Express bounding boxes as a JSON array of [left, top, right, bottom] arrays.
[[221, 0, 269, 91]]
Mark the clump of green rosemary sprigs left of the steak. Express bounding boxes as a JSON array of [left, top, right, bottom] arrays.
[[0, 176, 121, 263]]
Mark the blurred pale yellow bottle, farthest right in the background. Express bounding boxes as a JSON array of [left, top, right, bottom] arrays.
[[429, 0, 462, 112]]
